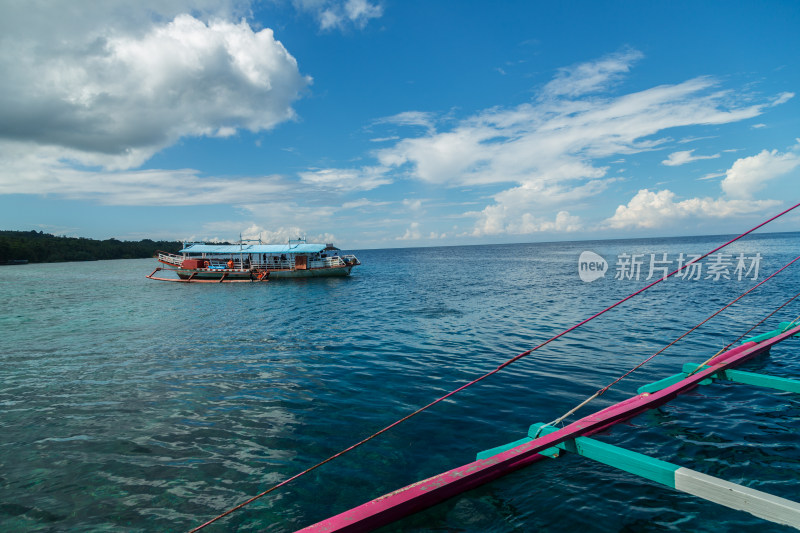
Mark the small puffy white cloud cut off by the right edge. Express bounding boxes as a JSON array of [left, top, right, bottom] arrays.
[[721, 150, 800, 198]]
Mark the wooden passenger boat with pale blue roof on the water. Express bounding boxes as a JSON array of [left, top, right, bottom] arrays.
[[147, 239, 361, 283]]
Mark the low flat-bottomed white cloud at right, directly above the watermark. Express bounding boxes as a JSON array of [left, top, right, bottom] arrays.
[[606, 189, 780, 229]]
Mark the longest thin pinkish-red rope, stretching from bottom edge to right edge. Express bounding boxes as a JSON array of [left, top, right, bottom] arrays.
[[189, 203, 800, 533]]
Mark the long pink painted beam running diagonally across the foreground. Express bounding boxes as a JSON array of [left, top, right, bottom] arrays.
[[301, 326, 800, 533]]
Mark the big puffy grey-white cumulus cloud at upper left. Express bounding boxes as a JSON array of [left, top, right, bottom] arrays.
[[0, 9, 310, 169]]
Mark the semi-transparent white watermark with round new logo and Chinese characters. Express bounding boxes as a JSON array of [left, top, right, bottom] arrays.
[[578, 250, 762, 283]]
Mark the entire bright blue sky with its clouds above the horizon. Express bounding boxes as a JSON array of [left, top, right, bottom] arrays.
[[0, 0, 800, 249]]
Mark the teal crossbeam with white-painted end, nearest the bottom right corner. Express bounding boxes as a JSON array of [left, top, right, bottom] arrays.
[[531, 424, 800, 528]]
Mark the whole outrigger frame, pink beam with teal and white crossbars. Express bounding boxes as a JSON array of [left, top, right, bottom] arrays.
[[301, 322, 800, 533]]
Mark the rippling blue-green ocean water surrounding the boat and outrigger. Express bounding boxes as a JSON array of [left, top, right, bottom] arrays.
[[0, 233, 800, 533]]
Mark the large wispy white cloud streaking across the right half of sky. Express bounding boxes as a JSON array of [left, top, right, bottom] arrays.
[[368, 50, 790, 235]]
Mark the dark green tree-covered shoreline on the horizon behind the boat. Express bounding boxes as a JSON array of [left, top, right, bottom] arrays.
[[0, 231, 182, 265]]
